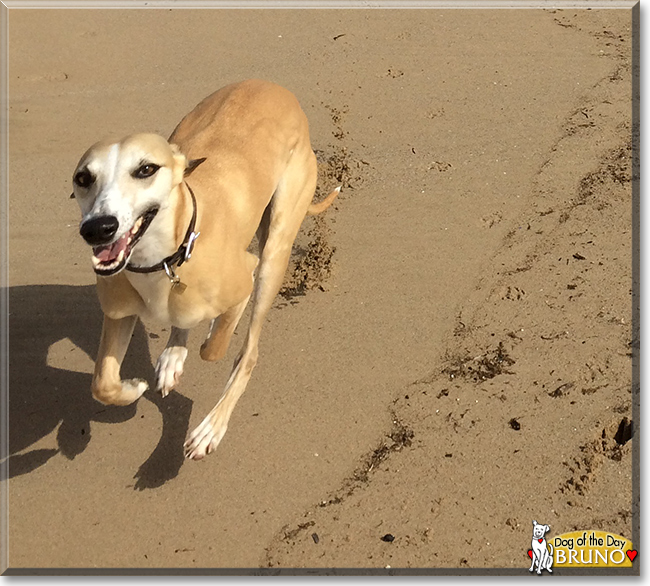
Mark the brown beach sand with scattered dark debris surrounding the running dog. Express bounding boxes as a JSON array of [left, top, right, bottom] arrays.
[[2, 4, 638, 574]]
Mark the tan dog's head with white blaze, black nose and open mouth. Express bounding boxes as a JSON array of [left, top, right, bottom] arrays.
[[73, 134, 186, 276]]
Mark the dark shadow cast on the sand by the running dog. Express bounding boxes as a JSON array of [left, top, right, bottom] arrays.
[[8, 285, 192, 490]]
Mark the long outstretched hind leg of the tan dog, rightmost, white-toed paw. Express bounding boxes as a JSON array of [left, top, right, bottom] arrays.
[[185, 153, 316, 460]]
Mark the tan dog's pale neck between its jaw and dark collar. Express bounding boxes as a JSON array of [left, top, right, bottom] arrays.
[[130, 182, 193, 267]]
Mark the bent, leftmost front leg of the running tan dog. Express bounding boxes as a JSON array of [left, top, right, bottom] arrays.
[[91, 315, 148, 405]]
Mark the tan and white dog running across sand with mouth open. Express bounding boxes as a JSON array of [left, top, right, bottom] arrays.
[[73, 80, 340, 459]]
